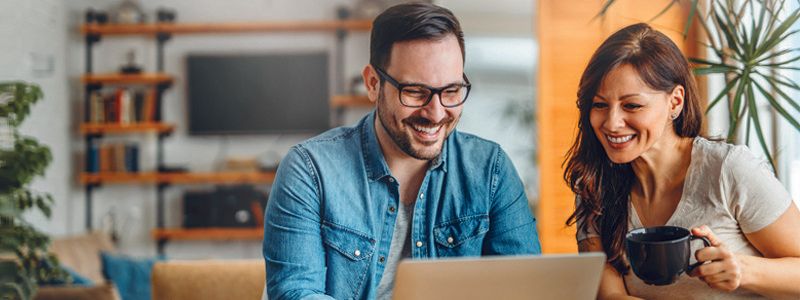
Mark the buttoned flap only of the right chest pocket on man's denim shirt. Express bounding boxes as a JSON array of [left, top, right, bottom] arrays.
[[433, 214, 489, 248]]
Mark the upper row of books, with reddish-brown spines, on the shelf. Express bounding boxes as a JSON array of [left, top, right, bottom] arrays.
[[89, 88, 159, 124]]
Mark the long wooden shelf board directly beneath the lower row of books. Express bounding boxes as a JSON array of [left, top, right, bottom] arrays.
[[80, 172, 275, 184]]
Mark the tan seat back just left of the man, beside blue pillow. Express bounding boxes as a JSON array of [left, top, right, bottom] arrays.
[[152, 259, 266, 300]]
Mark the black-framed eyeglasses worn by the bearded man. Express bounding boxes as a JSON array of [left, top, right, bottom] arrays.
[[372, 66, 472, 107]]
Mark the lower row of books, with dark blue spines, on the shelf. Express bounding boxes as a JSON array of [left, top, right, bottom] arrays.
[[86, 143, 139, 173]]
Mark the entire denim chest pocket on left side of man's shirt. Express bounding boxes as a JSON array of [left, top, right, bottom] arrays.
[[322, 221, 376, 299]]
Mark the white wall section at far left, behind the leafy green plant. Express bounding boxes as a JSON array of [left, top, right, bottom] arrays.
[[0, 0, 75, 239]]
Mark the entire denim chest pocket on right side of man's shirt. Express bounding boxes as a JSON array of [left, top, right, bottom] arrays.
[[433, 214, 489, 257]]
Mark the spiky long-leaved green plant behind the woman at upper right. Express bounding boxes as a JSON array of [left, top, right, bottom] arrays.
[[598, 0, 800, 166]]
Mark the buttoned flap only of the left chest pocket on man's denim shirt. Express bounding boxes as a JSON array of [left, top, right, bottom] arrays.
[[322, 221, 375, 261]]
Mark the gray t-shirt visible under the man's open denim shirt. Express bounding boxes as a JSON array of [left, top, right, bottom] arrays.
[[377, 203, 414, 300]]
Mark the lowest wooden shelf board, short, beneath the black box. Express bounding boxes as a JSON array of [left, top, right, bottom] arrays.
[[152, 227, 264, 240]]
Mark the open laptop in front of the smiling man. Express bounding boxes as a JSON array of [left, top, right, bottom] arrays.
[[392, 252, 606, 300]]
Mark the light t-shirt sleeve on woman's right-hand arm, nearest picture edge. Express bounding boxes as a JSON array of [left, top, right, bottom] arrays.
[[722, 146, 792, 233]]
